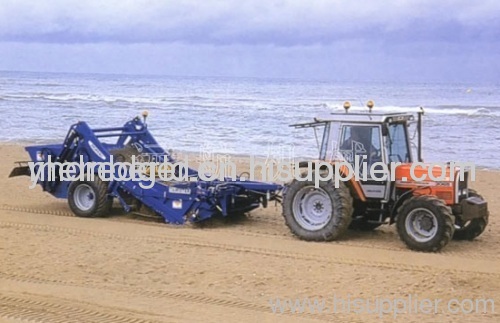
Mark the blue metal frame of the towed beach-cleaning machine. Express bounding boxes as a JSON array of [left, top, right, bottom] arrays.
[[22, 117, 282, 224]]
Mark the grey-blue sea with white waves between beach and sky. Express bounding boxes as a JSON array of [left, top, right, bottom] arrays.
[[0, 71, 500, 169]]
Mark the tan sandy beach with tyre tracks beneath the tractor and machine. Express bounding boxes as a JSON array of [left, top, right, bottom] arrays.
[[0, 144, 500, 322]]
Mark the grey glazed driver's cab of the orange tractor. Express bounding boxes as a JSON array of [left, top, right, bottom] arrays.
[[292, 111, 423, 203]]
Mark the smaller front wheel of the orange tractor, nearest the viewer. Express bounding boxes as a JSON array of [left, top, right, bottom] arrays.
[[396, 195, 455, 251]]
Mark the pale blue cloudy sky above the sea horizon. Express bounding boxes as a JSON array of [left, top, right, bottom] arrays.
[[0, 0, 500, 83]]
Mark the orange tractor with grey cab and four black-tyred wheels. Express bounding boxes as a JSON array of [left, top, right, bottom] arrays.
[[283, 101, 489, 251]]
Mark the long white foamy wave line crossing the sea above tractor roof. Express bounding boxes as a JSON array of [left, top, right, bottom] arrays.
[[0, 91, 500, 118]]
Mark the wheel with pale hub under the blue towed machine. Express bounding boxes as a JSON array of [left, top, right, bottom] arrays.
[[68, 176, 113, 218]]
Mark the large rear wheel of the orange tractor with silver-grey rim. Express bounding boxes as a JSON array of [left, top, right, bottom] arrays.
[[283, 176, 353, 241]]
